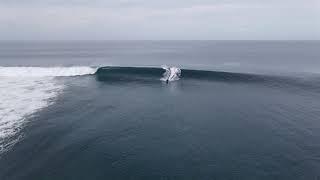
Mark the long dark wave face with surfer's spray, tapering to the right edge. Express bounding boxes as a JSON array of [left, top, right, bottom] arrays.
[[95, 66, 320, 92]]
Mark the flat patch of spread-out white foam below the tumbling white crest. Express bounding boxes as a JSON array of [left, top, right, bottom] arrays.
[[0, 76, 63, 154]]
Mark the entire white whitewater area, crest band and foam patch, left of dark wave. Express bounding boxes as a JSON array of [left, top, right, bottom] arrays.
[[0, 67, 96, 153]]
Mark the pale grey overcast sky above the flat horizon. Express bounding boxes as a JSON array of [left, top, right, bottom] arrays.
[[0, 0, 320, 40]]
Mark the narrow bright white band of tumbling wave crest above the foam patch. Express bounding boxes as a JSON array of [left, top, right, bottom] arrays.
[[0, 66, 97, 77]]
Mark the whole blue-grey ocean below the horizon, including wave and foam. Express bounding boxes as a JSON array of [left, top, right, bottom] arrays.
[[0, 41, 320, 180]]
